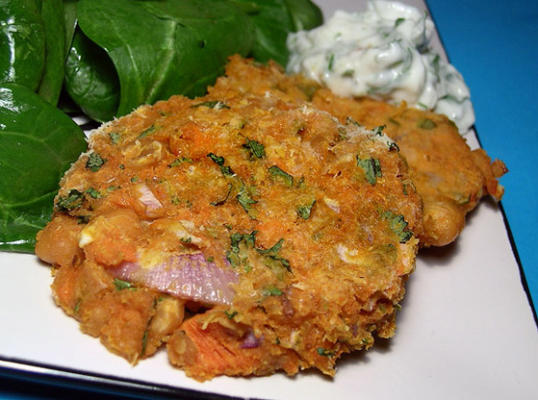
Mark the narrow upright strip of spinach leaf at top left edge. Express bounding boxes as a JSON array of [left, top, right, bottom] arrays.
[[37, 0, 65, 105]]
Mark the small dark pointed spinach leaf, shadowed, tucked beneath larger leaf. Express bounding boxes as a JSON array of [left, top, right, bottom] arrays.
[[65, 29, 120, 122]]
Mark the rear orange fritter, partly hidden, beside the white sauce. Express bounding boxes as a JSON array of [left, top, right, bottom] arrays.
[[216, 57, 507, 246]]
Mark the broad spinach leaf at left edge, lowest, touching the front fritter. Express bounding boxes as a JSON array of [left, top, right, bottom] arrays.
[[0, 83, 86, 252]]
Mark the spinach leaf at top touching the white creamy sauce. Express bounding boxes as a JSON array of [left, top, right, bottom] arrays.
[[234, 0, 323, 66]]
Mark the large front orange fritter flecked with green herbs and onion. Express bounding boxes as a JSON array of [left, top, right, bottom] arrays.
[[36, 55, 422, 380]]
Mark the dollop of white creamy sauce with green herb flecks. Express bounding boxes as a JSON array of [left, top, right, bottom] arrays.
[[287, 1, 475, 133]]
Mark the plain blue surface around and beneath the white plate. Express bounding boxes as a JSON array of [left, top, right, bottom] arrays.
[[0, 0, 538, 399]]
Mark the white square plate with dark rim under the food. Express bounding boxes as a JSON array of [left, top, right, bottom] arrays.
[[0, 0, 538, 400]]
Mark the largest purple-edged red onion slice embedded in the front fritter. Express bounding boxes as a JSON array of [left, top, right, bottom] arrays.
[[110, 253, 239, 304]]
